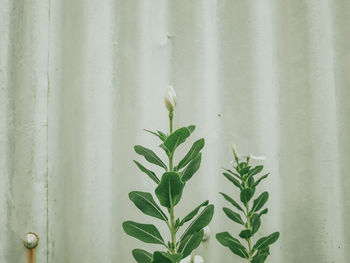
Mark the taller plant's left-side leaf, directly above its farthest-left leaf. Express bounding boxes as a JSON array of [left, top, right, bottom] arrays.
[[129, 191, 168, 221]]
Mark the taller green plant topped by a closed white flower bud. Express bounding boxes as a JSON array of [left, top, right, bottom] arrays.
[[123, 88, 214, 263]]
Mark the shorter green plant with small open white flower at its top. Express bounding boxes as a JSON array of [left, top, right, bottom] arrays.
[[216, 145, 280, 263]]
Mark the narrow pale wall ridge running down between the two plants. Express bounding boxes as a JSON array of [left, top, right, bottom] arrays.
[[194, 0, 222, 262]]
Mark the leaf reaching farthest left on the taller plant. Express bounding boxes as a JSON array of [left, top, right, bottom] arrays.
[[123, 221, 164, 245]]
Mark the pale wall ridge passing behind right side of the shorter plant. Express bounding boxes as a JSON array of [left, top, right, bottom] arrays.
[[249, 1, 286, 262]]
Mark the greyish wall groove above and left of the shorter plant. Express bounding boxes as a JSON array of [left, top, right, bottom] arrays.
[[216, 0, 256, 262]]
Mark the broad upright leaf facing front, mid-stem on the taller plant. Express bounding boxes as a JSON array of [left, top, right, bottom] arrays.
[[155, 172, 184, 208]]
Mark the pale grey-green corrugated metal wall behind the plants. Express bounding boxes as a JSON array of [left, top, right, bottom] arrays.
[[0, 0, 350, 263]]
